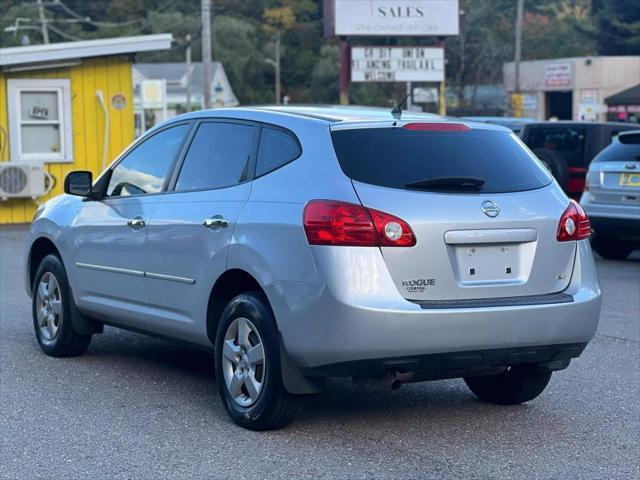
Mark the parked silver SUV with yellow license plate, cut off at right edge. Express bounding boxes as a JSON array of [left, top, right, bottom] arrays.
[[580, 130, 640, 260]]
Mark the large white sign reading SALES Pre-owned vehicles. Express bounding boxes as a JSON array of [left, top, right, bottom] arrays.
[[334, 0, 459, 36]]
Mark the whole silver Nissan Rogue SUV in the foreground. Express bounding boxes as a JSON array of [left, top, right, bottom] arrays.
[[26, 107, 600, 430]]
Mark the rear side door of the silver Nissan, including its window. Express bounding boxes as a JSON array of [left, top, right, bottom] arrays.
[[146, 121, 258, 344]]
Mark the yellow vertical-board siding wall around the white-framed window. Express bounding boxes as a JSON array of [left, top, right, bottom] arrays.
[[0, 57, 134, 224]]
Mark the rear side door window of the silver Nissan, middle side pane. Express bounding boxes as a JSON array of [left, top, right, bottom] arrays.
[[175, 122, 256, 191]]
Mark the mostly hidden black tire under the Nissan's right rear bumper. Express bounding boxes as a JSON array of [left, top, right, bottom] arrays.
[[464, 364, 551, 405]]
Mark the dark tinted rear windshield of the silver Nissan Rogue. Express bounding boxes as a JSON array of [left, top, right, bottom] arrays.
[[331, 128, 552, 193]]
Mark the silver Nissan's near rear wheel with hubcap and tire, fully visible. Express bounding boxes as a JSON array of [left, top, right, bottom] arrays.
[[215, 292, 302, 430]]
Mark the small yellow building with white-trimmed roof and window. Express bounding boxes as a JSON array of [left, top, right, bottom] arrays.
[[0, 34, 171, 224]]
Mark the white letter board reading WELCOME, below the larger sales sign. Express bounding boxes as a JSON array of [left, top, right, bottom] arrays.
[[351, 47, 444, 82]]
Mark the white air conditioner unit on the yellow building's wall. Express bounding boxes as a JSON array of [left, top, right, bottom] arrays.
[[0, 162, 47, 200]]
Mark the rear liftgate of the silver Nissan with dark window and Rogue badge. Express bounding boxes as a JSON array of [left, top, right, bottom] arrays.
[[332, 124, 576, 300]]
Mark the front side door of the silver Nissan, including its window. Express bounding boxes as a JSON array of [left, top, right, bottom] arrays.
[[70, 123, 191, 328]]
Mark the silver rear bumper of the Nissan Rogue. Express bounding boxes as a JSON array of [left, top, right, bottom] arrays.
[[266, 241, 601, 374]]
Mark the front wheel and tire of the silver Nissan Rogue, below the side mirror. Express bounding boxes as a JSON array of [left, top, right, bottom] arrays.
[[32, 255, 91, 357]]
